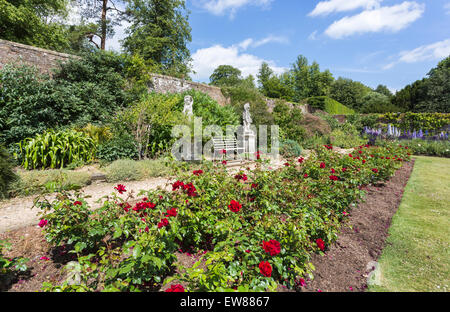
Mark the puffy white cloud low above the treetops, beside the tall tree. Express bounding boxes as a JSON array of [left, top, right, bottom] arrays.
[[192, 39, 287, 81]]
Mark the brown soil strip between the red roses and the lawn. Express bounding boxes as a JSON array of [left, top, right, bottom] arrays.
[[302, 160, 414, 292]]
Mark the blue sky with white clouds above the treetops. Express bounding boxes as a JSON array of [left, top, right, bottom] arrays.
[[104, 0, 450, 90]]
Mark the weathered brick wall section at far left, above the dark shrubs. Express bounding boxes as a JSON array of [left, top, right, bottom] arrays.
[[0, 39, 78, 74]]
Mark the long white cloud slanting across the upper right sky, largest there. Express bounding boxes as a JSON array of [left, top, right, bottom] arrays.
[[325, 1, 425, 39]]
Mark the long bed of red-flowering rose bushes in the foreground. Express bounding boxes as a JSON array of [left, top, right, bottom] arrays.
[[37, 145, 409, 291]]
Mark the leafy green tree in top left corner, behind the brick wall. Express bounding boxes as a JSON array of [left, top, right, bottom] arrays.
[[0, 0, 69, 52]]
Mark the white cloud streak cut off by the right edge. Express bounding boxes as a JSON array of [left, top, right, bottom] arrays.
[[383, 39, 450, 70]]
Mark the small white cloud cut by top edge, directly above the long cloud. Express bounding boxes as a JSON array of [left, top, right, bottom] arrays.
[[308, 0, 383, 16]]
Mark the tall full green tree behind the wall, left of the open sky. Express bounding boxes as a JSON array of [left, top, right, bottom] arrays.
[[122, 0, 192, 77]]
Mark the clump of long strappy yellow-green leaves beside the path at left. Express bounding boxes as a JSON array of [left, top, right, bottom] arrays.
[[17, 130, 96, 169]]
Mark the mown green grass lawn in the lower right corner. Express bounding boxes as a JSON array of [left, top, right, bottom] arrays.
[[369, 156, 450, 292]]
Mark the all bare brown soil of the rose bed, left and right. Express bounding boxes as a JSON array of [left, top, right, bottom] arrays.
[[0, 161, 414, 292]]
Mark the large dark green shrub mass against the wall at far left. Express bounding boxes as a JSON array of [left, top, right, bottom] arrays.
[[0, 52, 135, 147]]
